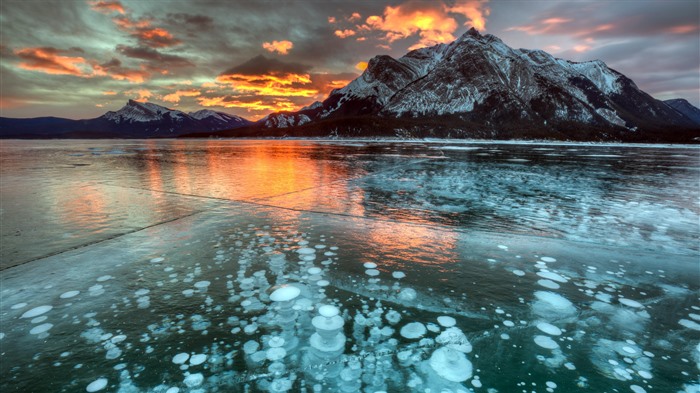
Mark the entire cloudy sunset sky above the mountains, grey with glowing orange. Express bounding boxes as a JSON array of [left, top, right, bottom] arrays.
[[0, 0, 700, 120]]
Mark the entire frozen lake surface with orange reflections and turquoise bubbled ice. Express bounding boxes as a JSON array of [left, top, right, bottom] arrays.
[[0, 140, 700, 393]]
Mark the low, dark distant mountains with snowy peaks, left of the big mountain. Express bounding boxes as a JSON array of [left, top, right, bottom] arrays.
[[0, 100, 253, 138]]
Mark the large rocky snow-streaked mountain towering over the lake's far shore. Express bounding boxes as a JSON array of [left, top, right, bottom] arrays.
[[261, 29, 696, 139]]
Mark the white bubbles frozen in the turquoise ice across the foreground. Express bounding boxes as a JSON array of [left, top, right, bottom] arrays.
[[0, 227, 700, 393]]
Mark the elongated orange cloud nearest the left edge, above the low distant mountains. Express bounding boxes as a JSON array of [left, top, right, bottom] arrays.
[[15, 47, 92, 77]]
